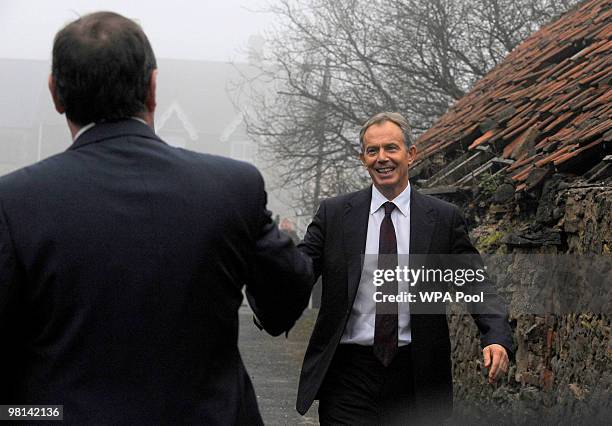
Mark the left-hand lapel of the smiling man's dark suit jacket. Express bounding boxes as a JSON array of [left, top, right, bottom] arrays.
[[343, 186, 372, 307]]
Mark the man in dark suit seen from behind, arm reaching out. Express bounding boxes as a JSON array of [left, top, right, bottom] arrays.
[[0, 12, 312, 425]]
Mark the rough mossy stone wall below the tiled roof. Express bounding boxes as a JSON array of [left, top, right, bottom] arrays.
[[449, 176, 612, 425]]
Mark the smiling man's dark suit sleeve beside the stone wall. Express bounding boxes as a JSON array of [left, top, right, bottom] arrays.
[[451, 208, 514, 355]]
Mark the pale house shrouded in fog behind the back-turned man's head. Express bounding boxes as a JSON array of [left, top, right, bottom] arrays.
[[0, 59, 257, 175]]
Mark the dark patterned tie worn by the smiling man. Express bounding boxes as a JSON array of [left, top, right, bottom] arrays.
[[373, 201, 398, 367]]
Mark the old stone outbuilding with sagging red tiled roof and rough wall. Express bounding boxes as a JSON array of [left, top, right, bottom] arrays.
[[410, 0, 612, 424]]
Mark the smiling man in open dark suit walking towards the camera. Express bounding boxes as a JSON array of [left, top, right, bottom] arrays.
[[297, 113, 512, 425]]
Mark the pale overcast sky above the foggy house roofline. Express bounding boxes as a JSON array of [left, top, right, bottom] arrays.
[[0, 0, 272, 61]]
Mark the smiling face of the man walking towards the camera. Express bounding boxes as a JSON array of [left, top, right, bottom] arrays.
[[360, 121, 416, 199]]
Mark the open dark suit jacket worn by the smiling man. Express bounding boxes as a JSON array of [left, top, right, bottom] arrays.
[[297, 187, 512, 417]]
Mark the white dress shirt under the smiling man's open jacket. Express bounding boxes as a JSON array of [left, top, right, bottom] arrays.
[[340, 183, 411, 346]]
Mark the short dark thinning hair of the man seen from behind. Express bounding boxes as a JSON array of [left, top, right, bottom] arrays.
[[51, 12, 157, 126]]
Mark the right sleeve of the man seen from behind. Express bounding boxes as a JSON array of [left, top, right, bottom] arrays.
[[246, 173, 312, 336]]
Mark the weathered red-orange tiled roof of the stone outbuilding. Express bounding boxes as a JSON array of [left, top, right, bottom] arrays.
[[417, 0, 612, 191]]
